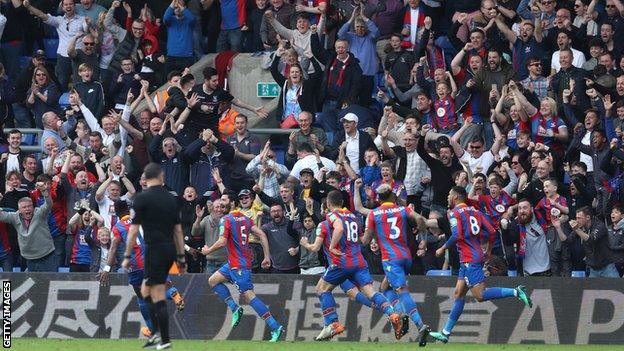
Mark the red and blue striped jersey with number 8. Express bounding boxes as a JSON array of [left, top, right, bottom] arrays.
[[446, 204, 496, 263]]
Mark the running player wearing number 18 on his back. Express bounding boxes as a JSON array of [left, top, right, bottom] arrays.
[[304, 190, 401, 340]]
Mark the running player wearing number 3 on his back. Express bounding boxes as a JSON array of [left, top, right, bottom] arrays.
[[362, 184, 430, 347]]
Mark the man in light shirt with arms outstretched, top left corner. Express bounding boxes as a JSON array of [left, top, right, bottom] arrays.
[[24, 0, 89, 91]]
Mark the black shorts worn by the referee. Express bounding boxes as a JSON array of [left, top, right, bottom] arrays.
[[145, 243, 176, 286]]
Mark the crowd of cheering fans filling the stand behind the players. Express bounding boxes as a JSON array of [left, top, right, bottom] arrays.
[[0, 0, 624, 277]]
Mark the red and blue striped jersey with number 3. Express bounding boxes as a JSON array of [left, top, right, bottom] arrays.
[[366, 202, 412, 261]]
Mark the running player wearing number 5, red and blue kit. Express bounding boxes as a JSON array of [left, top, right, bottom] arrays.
[[202, 197, 285, 342]]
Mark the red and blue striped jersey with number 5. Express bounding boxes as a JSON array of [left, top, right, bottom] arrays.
[[219, 210, 254, 269]]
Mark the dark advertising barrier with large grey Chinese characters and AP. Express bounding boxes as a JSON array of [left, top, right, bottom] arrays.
[[0, 273, 624, 344]]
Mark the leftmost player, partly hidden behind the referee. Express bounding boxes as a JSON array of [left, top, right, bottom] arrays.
[[99, 200, 184, 344]]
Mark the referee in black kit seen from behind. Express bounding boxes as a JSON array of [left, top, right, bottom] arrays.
[[121, 163, 186, 350]]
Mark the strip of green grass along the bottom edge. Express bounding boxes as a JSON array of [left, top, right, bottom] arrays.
[[11, 338, 624, 351]]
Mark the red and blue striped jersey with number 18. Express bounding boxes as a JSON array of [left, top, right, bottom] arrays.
[[323, 208, 368, 268]]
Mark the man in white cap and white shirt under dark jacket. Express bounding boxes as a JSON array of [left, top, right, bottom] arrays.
[[330, 113, 377, 174]]
